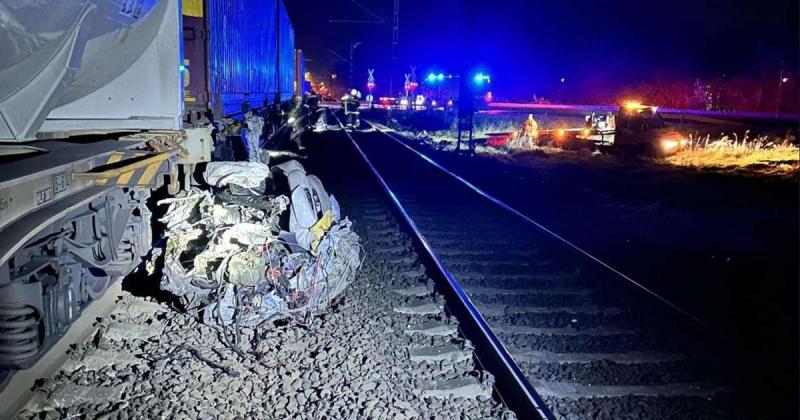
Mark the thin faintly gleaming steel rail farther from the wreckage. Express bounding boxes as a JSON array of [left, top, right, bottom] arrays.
[[365, 121, 734, 342]]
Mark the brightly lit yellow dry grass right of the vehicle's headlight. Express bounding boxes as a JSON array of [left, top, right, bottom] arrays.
[[666, 132, 800, 175]]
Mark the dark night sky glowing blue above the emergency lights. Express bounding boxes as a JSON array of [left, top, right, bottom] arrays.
[[285, 0, 800, 98]]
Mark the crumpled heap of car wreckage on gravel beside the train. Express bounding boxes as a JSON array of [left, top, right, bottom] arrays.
[[159, 161, 362, 327]]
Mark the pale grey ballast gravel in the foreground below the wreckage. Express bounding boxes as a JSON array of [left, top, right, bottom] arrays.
[[18, 210, 514, 419]]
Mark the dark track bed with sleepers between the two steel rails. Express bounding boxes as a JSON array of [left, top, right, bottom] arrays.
[[332, 112, 747, 418]]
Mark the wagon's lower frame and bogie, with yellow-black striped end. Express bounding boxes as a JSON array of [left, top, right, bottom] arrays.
[[0, 127, 213, 371]]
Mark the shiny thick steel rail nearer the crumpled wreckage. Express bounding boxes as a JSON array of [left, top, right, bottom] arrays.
[[333, 113, 555, 420]]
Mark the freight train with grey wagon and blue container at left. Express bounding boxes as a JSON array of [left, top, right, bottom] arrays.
[[0, 0, 303, 369]]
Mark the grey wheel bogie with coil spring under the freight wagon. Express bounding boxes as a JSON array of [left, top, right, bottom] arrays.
[[0, 188, 152, 368]]
